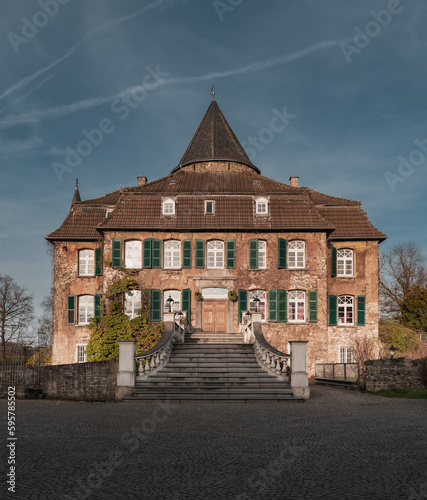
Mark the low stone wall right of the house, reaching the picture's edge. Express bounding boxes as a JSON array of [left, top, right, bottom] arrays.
[[366, 358, 427, 392]]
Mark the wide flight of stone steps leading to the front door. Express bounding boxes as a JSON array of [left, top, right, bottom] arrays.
[[124, 333, 303, 402]]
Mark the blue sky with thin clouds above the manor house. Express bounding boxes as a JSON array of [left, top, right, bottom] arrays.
[[0, 0, 427, 314]]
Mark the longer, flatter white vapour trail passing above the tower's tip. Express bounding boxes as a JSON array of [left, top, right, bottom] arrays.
[[0, 40, 339, 128]]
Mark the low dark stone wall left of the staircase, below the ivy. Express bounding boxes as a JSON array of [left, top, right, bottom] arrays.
[[40, 361, 119, 401]]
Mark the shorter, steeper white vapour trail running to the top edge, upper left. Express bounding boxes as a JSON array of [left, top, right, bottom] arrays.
[[0, 0, 179, 104]]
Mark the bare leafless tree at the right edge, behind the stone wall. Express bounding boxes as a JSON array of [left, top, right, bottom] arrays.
[[380, 242, 427, 318]]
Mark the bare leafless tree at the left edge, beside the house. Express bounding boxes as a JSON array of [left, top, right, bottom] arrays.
[[0, 274, 34, 359]]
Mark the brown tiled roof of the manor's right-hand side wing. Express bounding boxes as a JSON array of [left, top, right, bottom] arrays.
[[316, 206, 387, 241]]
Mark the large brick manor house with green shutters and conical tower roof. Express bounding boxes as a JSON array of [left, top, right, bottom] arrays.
[[47, 99, 385, 373]]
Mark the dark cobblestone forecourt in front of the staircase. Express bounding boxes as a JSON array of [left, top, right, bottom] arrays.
[[0, 387, 427, 500]]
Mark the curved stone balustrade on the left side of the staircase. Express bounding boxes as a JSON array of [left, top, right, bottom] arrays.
[[135, 313, 188, 380]]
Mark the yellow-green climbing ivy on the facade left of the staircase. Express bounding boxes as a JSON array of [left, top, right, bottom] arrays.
[[86, 278, 164, 361]]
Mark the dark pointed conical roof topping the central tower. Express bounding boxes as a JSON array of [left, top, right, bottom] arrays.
[[172, 99, 260, 173]]
